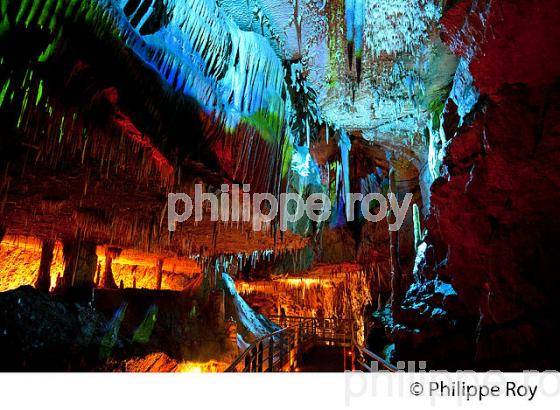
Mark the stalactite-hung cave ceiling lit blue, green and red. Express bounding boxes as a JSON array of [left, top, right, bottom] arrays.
[[2, 0, 457, 256]]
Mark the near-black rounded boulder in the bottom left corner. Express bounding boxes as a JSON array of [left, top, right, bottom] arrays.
[[0, 286, 105, 371]]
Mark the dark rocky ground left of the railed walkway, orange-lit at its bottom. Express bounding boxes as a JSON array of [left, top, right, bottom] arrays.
[[0, 282, 270, 372]]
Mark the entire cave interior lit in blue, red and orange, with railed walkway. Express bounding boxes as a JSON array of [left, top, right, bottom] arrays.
[[0, 0, 560, 372]]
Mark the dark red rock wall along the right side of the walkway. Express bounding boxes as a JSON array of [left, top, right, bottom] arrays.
[[393, 0, 560, 370]]
